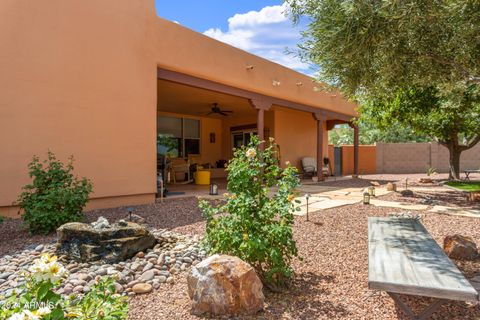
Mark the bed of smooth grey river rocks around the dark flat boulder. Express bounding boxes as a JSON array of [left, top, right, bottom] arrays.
[[0, 229, 207, 302]]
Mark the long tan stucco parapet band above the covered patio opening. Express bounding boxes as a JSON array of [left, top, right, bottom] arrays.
[[152, 21, 357, 117]]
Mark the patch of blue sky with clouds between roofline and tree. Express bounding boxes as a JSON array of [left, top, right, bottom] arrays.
[[155, 0, 312, 74]]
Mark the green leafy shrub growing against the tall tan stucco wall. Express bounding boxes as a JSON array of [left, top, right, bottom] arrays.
[[17, 151, 92, 234]]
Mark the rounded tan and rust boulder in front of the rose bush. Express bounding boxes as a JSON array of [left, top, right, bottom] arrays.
[[188, 255, 265, 315]]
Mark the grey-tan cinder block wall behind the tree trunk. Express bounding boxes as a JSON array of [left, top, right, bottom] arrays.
[[376, 142, 480, 173]]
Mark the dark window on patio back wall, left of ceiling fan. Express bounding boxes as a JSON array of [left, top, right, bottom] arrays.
[[157, 116, 200, 158]]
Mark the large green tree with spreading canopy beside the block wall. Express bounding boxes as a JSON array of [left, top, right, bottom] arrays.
[[286, 0, 480, 179]]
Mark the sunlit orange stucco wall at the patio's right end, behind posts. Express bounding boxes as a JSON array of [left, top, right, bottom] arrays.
[[275, 107, 328, 169]]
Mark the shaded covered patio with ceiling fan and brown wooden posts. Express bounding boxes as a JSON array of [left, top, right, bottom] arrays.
[[157, 68, 359, 195]]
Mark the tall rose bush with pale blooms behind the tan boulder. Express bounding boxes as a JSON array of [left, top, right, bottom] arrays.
[[199, 137, 299, 286]]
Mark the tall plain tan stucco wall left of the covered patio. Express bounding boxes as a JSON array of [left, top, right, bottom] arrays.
[[0, 0, 156, 218]]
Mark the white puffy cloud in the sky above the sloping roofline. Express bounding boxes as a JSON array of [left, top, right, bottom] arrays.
[[204, 5, 312, 74]]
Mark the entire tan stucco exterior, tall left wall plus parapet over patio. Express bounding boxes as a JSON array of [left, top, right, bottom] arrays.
[[0, 0, 356, 218]]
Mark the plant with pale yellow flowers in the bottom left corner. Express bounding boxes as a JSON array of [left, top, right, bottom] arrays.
[[0, 254, 128, 320]]
